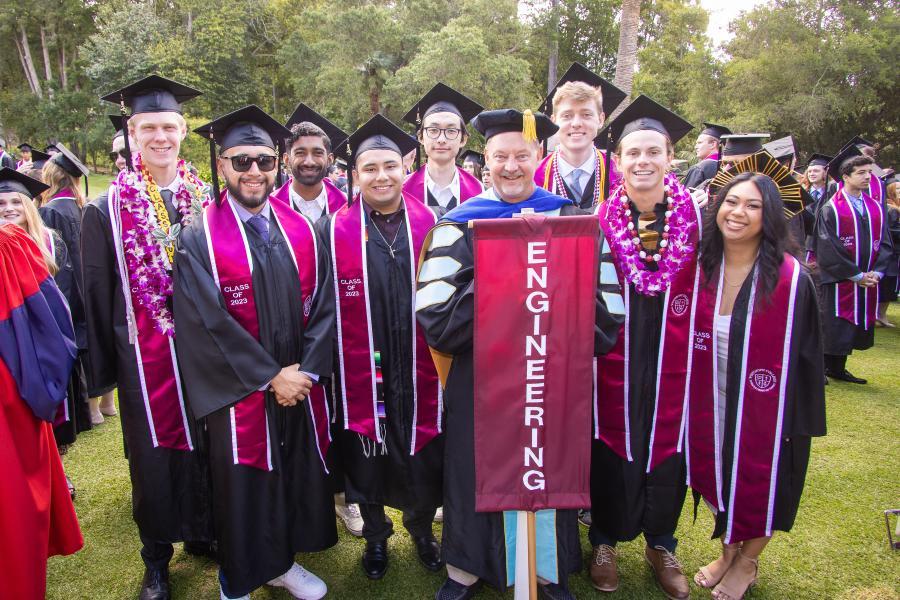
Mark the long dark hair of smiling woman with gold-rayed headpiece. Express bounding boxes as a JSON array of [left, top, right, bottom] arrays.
[[699, 173, 799, 304]]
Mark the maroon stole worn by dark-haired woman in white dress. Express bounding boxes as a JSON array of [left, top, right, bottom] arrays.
[[685, 254, 801, 544]]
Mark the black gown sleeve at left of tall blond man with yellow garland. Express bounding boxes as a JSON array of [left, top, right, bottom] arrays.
[[81, 196, 119, 396]]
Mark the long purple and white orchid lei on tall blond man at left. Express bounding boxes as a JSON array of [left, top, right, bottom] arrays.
[[116, 154, 203, 337]]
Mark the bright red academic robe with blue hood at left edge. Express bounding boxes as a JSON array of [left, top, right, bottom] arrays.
[[0, 225, 84, 600]]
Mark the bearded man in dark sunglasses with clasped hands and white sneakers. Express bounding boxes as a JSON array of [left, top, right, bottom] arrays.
[[174, 106, 337, 600]]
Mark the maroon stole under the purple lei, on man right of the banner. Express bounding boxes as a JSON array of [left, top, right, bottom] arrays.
[[594, 198, 700, 473]]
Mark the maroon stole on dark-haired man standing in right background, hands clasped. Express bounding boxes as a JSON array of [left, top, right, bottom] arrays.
[[829, 184, 884, 329]]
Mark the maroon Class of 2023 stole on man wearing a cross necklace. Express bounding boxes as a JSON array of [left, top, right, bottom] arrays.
[[331, 193, 443, 454]]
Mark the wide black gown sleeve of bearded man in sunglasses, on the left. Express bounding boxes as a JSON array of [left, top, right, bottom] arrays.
[[173, 223, 281, 419]]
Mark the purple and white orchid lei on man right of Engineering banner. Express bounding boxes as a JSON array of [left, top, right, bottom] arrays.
[[601, 173, 699, 296]]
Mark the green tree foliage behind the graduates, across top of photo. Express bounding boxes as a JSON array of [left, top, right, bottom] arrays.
[[0, 0, 900, 173]]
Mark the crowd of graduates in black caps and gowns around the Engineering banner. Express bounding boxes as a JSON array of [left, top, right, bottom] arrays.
[[0, 64, 900, 600]]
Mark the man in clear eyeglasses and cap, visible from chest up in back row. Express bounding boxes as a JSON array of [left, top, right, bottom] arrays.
[[403, 83, 484, 210]]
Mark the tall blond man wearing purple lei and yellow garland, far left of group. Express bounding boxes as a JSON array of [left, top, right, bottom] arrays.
[[81, 75, 214, 600]]
